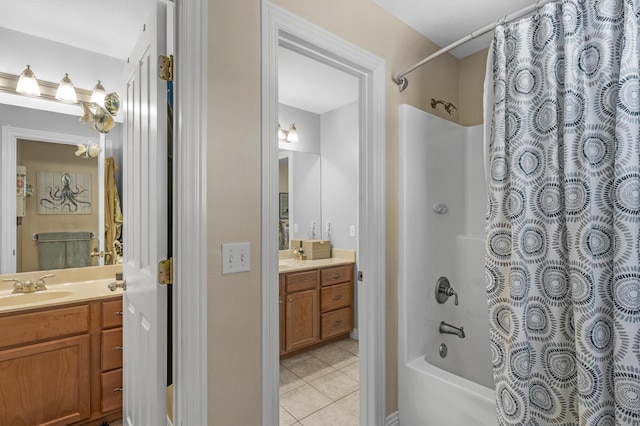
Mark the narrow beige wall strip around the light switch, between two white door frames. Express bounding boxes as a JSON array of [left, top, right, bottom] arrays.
[[207, 0, 261, 426]]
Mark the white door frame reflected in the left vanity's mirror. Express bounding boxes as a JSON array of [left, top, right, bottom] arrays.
[[0, 126, 104, 274]]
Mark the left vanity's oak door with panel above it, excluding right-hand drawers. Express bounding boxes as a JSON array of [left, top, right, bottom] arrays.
[[0, 305, 90, 426]]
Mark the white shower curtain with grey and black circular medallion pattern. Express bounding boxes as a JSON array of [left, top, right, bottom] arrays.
[[485, 0, 640, 426]]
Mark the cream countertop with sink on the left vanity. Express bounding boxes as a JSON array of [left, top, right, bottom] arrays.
[[0, 265, 122, 314]]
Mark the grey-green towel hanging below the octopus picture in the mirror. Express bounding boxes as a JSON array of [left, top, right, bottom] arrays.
[[38, 232, 91, 270]]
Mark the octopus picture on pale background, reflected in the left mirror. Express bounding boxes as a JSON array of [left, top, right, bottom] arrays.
[[37, 171, 91, 214]]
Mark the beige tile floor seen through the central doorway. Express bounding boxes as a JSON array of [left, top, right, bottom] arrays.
[[280, 339, 360, 426]]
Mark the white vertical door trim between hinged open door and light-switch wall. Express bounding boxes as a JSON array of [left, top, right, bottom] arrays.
[[173, 0, 209, 426]]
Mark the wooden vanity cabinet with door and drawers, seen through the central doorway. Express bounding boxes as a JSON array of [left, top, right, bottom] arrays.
[[279, 264, 354, 355]]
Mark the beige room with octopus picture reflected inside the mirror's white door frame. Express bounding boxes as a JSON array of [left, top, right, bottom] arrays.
[[16, 139, 101, 272]]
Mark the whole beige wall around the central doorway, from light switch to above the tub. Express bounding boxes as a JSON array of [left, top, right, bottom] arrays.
[[207, 0, 484, 425]]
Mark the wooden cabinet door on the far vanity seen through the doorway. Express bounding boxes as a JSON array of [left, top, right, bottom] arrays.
[[285, 289, 319, 352]]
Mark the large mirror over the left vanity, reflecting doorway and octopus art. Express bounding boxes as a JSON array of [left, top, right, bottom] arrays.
[[0, 105, 118, 274]]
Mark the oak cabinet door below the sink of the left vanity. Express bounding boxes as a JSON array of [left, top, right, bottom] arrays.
[[0, 335, 90, 426]]
